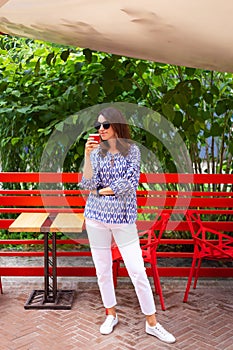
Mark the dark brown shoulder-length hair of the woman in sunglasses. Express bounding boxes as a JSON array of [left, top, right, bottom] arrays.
[[97, 107, 132, 156]]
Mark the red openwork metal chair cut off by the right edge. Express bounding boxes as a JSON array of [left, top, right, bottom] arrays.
[[183, 211, 233, 302]]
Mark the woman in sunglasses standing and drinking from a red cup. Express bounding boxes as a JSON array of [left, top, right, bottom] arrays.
[[80, 108, 175, 343]]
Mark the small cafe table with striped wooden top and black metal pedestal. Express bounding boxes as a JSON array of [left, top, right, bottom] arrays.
[[9, 213, 84, 310]]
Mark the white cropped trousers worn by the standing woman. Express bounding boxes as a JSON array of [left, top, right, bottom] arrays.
[[86, 219, 156, 315]]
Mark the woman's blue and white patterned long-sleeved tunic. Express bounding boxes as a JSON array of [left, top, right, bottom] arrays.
[[80, 144, 141, 224]]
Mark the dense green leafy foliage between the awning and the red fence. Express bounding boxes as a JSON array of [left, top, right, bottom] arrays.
[[0, 36, 233, 173]]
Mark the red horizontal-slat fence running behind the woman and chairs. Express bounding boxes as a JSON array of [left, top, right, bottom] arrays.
[[0, 173, 233, 298]]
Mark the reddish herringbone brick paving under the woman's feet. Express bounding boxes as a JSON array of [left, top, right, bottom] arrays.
[[0, 277, 233, 350]]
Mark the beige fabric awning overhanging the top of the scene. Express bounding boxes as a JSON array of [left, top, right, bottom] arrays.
[[0, 0, 233, 72]]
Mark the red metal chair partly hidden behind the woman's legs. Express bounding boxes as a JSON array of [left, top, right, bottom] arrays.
[[112, 214, 170, 310]]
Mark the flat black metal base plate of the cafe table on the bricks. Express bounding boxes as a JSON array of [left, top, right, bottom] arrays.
[[24, 289, 75, 310]]
